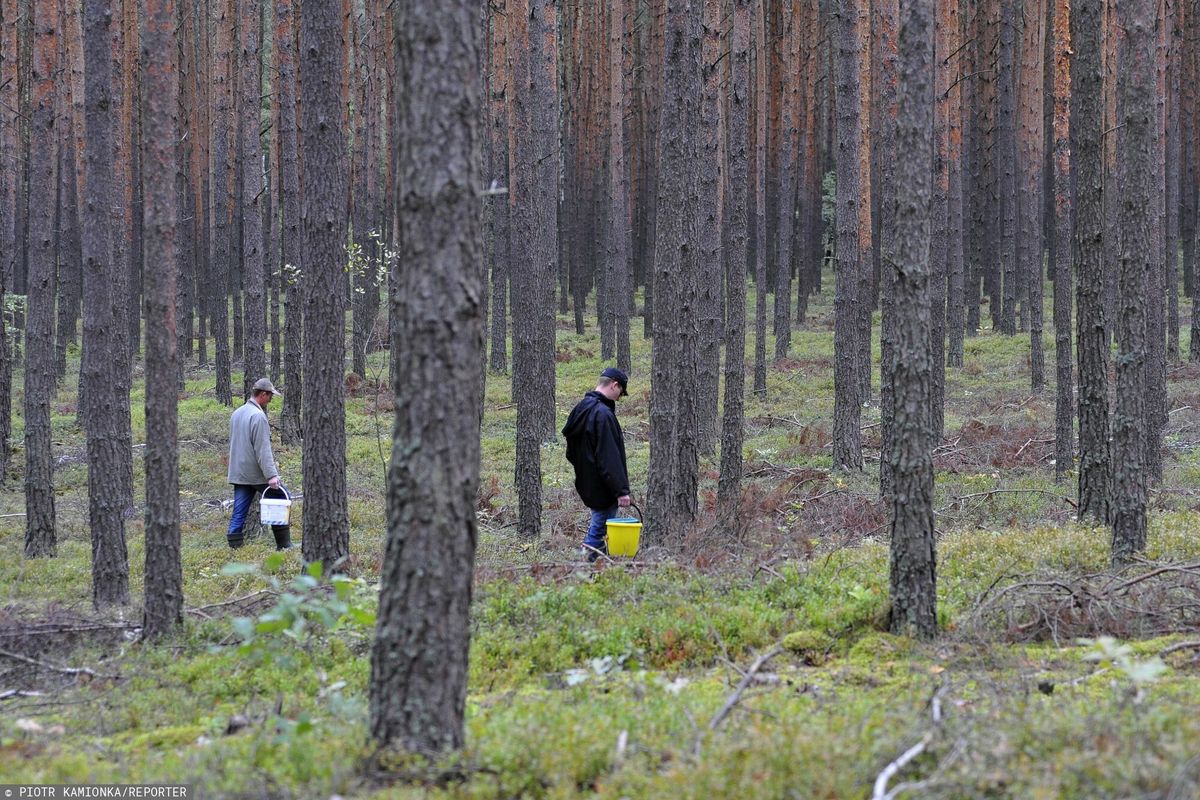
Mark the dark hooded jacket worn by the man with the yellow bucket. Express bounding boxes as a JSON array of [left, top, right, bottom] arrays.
[[563, 391, 629, 511]]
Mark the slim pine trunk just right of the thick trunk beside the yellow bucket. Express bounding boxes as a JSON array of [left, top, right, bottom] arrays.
[[716, 0, 751, 525]]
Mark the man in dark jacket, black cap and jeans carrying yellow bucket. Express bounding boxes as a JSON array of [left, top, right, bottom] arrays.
[[563, 367, 630, 561]]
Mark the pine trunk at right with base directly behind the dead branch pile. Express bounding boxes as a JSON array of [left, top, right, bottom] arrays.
[[1104, 0, 1157, 565]]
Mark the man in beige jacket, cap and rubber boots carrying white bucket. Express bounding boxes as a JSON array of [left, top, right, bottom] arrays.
[[227, 378, 292, 551]]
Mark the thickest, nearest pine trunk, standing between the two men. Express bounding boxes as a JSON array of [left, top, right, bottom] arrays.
[[371, 0, 480, 753]]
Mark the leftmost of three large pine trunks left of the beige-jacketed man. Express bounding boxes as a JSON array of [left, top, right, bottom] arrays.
[[24, 2, 61, 558]]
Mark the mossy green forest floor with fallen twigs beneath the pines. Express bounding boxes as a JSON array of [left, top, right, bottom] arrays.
[[0, 279, 1200, 799]]
